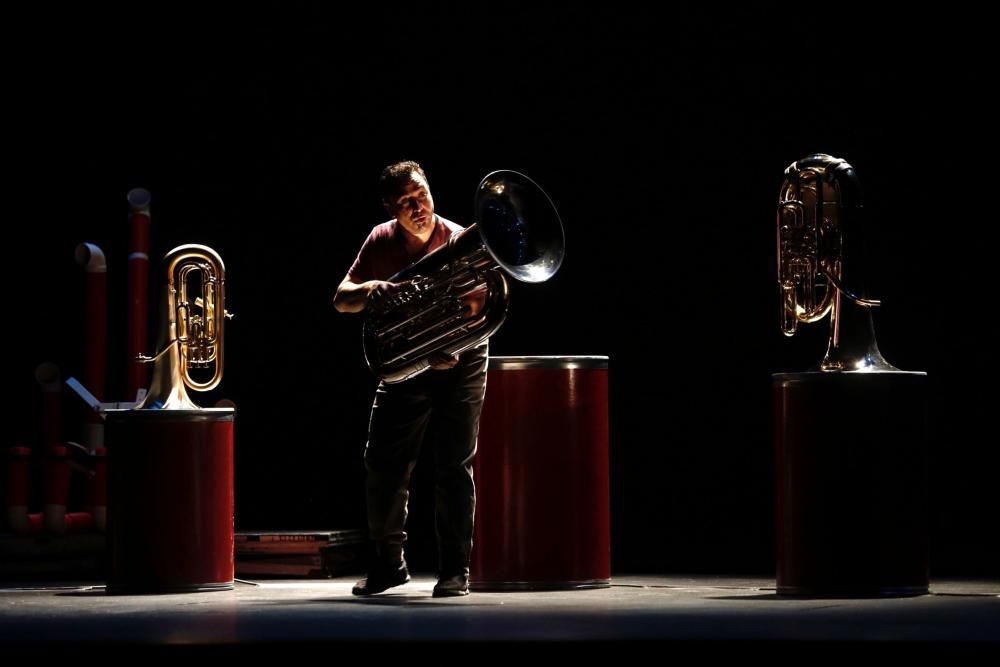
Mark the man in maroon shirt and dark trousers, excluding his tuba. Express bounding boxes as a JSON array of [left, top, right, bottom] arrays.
[[333, 162, 488, 597]]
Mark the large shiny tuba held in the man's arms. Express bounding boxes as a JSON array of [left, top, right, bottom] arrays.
[[364, 171, 565, 383]]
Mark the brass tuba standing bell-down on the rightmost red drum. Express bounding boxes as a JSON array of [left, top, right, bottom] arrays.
[[778, 153, 898, 371]]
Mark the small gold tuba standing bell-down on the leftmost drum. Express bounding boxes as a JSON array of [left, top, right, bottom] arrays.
[[136, 244, 232, 410]]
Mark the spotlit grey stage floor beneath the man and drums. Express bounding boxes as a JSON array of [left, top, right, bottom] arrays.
[[0, 575, 1000, 652]]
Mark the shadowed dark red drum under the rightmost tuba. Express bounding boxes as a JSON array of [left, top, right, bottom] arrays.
[[774, 371, 928, 596]]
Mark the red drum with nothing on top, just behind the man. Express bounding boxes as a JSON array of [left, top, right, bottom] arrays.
[[470, 357, 611, 590]]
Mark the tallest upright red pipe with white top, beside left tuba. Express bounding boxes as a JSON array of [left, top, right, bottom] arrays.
[[125, 188, 150, 401]]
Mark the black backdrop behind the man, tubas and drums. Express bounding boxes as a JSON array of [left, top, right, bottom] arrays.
[[4, 3, 1000, 575]]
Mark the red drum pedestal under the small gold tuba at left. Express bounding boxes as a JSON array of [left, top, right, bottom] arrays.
[[106, 408, 235, 593]]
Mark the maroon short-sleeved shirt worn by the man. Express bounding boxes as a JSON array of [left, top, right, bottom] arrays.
[[347, 214, 463, 283]]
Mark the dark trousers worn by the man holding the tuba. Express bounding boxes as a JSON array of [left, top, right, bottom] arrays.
[[365, 345, 489, 572]]
